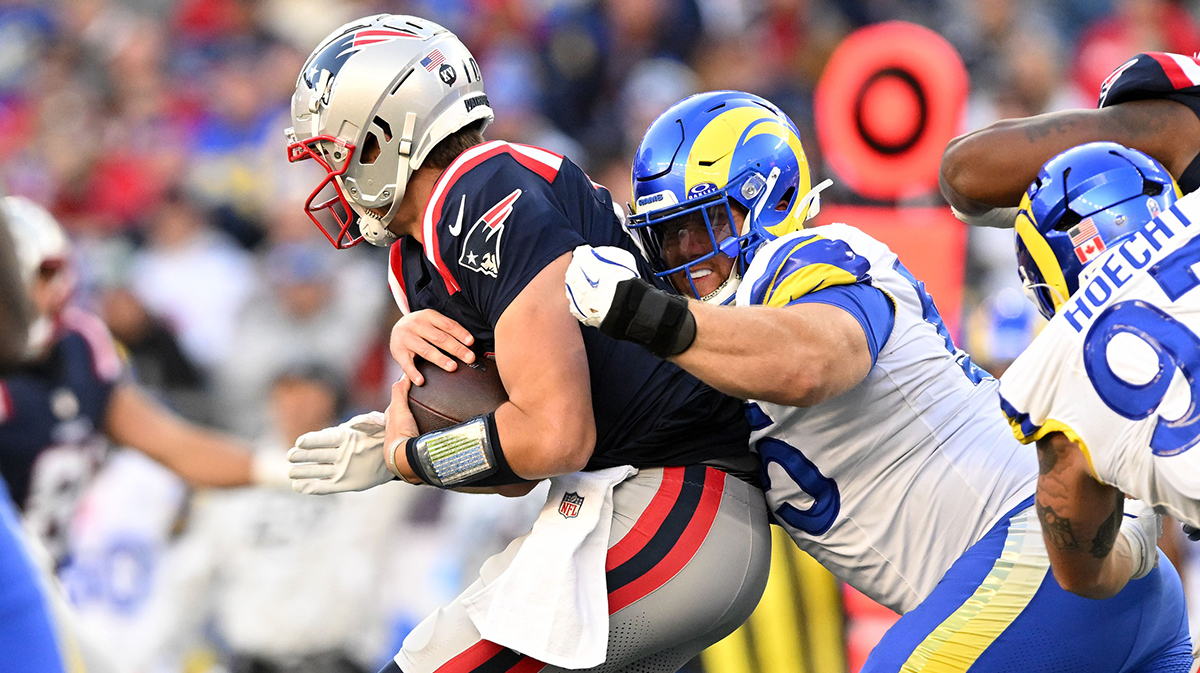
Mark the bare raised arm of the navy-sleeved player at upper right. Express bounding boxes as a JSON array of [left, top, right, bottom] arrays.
[[938, 100, 1200, 218]]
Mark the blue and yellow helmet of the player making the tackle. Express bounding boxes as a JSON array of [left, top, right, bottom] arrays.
[[629, 91, 828, 304]]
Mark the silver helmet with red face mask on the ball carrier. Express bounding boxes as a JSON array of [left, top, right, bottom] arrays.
[[286, 14, 492, 248]]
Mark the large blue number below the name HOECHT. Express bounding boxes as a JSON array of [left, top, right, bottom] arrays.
[[1084, 239, 1200, 456]]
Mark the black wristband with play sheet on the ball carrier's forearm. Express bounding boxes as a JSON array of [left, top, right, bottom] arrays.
[[404, 413, 524, 488]]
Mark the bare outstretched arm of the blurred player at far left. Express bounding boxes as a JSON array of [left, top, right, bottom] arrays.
[[104, 381, 258, 486]]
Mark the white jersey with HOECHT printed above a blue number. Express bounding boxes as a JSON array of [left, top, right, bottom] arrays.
[[1001, 192, 1200, 525]]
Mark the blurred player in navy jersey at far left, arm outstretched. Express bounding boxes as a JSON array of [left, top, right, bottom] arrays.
[[0, 197, 287, 564]]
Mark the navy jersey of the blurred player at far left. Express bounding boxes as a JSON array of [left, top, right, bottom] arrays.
[[0, 310, 124, 557]]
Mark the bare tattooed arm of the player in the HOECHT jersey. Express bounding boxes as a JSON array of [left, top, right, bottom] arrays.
[[1037, 432, 1134, 599]]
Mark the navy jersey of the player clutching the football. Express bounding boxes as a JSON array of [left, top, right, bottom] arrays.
[[390, 142, 749, 469]]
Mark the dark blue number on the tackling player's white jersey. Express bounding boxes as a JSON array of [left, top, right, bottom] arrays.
[[745, 403, 841, 535]]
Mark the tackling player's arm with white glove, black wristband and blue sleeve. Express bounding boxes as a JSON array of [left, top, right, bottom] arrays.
[[566, 242, 894, 407]]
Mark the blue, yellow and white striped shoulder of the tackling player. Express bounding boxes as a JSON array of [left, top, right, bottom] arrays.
[[738, 232, 871, 306]]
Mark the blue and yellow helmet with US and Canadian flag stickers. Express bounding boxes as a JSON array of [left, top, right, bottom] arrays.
[[1016, 143, 1180, 319]]
